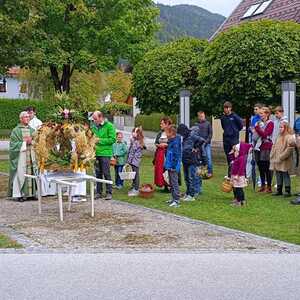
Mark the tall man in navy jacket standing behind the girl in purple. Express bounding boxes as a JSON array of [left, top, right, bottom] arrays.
[[221, 101, 243, 177]]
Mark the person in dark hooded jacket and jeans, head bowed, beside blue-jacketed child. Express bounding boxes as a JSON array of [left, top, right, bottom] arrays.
[[177, 124, 205, 201]]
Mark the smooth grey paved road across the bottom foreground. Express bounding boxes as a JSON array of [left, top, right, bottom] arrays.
[[0, 253, 300, 300]]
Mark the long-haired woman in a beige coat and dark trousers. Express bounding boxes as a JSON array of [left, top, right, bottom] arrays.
[[270, 121, 295, 197]]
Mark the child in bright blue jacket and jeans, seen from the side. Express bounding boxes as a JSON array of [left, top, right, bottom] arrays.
[[165, 126, 182, 207]]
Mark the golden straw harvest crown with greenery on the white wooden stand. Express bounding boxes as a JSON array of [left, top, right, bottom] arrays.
[[34, 108, 98, 173]]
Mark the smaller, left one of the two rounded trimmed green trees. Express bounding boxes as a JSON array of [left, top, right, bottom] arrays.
[[133, 38, 207, 114]]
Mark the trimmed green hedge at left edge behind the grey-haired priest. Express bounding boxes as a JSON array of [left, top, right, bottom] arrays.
[[0, 99, 52, 130]]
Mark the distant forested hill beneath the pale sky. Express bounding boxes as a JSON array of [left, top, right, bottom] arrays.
[[158, 4, 225, 42]]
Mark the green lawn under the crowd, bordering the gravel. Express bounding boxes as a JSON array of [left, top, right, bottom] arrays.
[[0, 157, 300, 244]]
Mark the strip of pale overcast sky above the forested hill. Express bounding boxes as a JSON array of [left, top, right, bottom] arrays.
[[156, 0, 241, 17]]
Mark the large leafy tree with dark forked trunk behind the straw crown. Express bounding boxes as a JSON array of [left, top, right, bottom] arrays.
[[0, 0, 158, 93]]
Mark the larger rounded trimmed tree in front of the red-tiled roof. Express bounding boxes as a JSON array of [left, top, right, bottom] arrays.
[[198, 20, 300, 117]]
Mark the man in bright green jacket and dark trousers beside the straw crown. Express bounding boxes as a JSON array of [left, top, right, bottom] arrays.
[[92, 111, 116, 200]]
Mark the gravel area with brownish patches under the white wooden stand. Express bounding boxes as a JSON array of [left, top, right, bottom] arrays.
[[0, 182, 300, 252]]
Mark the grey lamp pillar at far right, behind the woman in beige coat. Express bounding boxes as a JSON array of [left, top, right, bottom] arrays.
[[281, 81, 296, 126]]
